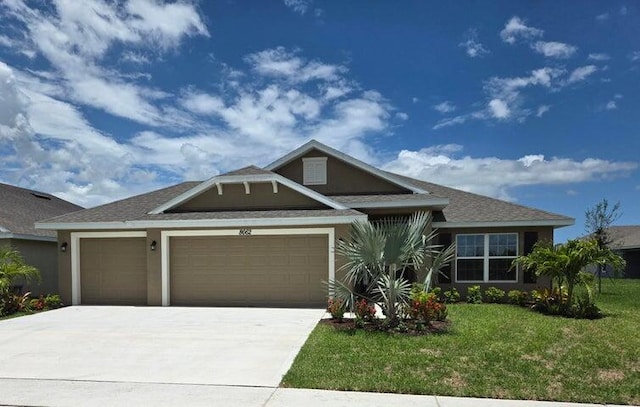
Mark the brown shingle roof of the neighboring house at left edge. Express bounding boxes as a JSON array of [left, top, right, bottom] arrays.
[[0, 183, 82, 240]]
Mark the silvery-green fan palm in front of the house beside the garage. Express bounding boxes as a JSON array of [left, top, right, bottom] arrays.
[[328, 212, 455, 324]]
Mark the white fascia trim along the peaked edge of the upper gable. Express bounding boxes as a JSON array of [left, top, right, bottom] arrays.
[[265, 140, 429, 194]]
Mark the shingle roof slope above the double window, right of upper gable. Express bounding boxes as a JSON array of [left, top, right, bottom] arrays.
[[393, 174, 573, 223]]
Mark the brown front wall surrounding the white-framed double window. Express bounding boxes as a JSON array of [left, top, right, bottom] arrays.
[[440, 227, 553, 296]]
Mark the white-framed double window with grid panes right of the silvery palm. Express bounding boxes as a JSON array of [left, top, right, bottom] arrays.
[[456, 233, 518, 282]]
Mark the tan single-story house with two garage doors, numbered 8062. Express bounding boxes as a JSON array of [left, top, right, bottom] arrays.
[[38, 141, 574, 306]]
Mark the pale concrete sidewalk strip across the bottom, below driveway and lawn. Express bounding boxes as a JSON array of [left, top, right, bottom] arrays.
[[0, 378, 632, 407]]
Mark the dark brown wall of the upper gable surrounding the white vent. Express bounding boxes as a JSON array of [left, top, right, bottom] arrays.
[[276, 150, 410, 195]]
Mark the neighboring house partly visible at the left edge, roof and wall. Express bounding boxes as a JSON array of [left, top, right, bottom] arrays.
[[0, 183, 82, 296]]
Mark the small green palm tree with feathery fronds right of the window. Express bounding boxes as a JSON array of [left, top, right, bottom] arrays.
[[514, 239, 625, 309]]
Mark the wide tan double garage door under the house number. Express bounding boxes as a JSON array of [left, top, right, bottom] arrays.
[[169, 235, 329, 307]]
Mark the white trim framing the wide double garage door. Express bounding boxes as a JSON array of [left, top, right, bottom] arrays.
[[160, 228, 336, 307]]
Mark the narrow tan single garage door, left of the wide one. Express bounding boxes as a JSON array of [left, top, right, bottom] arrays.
[[80, 237, 147, 305]]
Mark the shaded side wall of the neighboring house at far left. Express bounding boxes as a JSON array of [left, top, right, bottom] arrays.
[[0, 239, 58, 297]]
